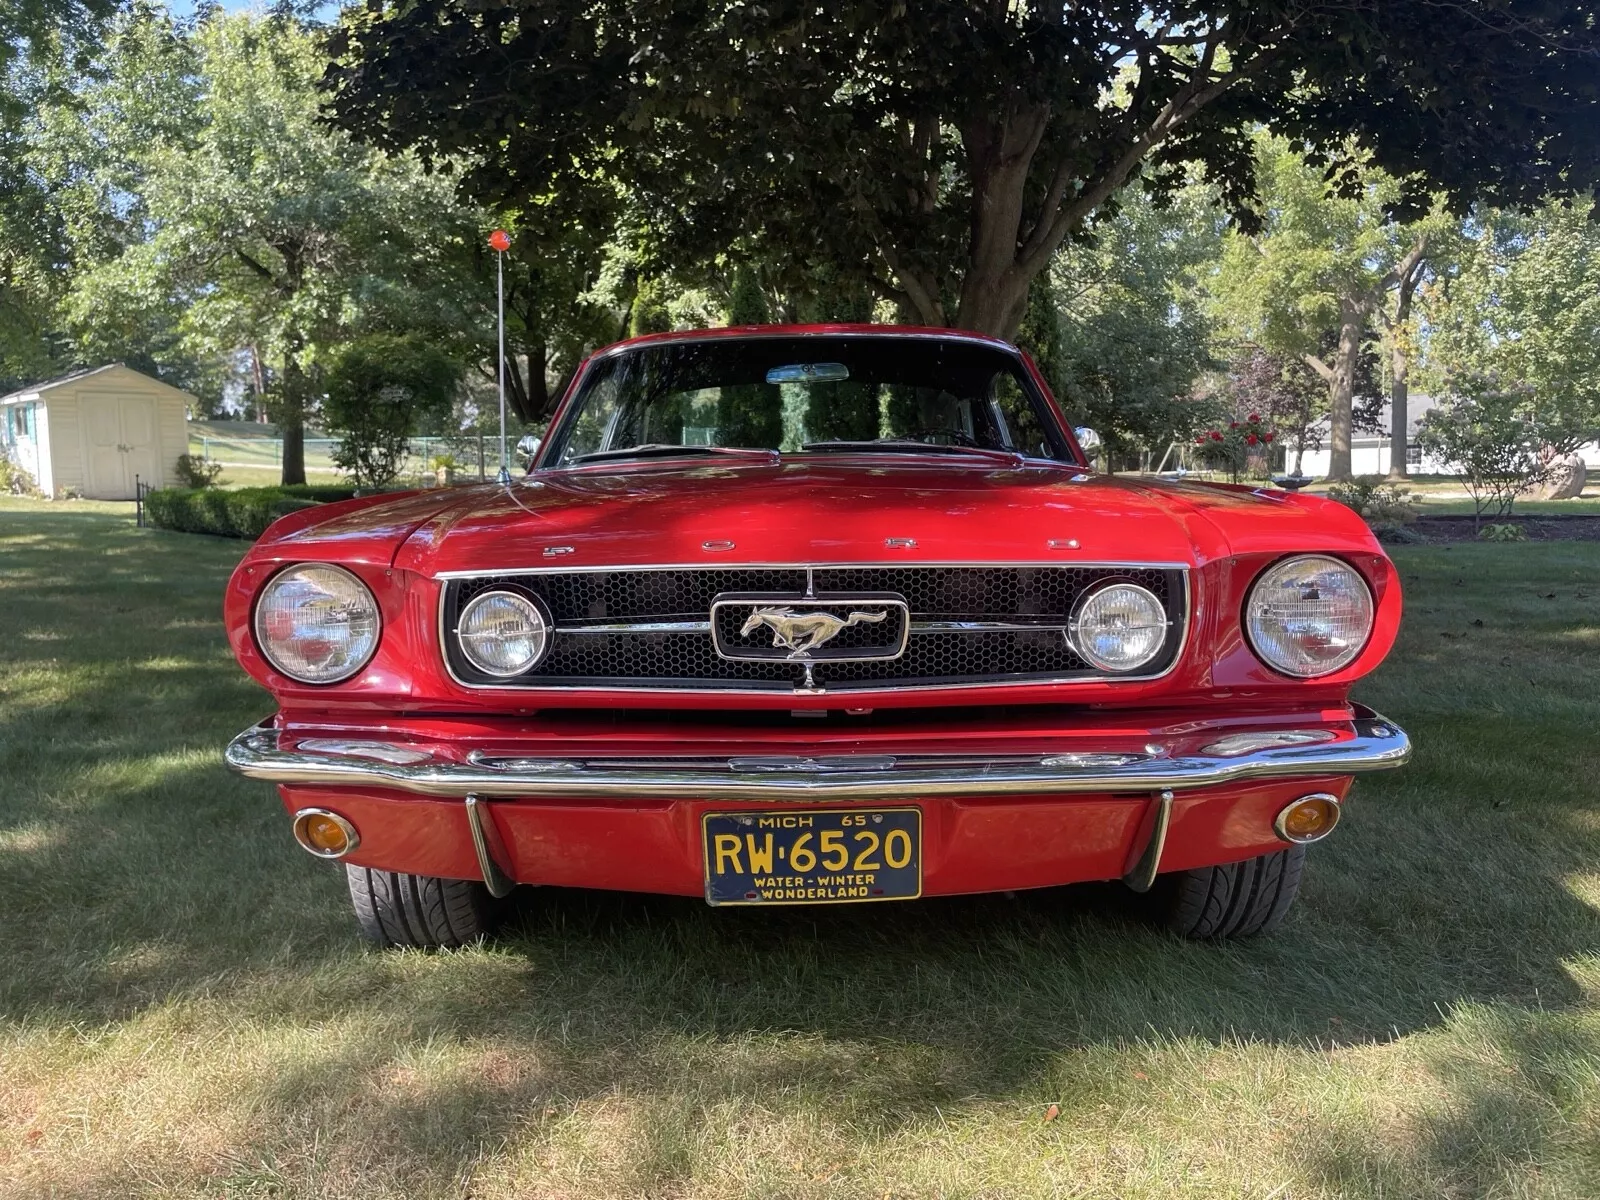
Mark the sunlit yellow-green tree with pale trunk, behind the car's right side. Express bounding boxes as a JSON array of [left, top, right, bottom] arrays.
[[1213, 134, 1446, 480]]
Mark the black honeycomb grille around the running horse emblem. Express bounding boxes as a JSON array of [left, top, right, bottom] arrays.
[[440, 566, 1189, 693]]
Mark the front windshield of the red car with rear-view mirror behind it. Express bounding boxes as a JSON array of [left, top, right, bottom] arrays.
[[547, 334, 1072, 466]]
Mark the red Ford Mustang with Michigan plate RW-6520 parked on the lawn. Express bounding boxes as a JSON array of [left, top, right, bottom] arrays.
[[227, 326, 1410, 946]]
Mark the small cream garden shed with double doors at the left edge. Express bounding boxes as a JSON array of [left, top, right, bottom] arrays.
[[0, 363, 195, 499]]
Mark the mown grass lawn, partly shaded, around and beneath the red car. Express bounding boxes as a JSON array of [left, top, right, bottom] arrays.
[[0, 499, 1600, 1200]]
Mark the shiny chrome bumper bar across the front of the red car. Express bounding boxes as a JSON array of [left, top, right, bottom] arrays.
[[227, 706, 1411, 802]]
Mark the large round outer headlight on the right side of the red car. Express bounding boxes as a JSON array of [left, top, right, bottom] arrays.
[[1245, 554, 1373, 678]]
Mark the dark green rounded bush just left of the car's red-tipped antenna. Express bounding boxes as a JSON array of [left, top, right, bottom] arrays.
[[323, 334, 461, 488]]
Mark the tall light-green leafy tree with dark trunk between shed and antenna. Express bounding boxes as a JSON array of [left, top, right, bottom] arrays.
[[64, 10, 480, 483]]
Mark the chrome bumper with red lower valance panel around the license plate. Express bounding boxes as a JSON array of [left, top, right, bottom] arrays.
[[227, 709, 1411, 896]]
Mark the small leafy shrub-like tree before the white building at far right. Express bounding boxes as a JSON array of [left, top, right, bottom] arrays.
[[1416, 374, 1549, 520]]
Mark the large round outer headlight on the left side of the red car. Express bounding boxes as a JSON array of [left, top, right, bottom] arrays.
[[256, 563, 379, 683]]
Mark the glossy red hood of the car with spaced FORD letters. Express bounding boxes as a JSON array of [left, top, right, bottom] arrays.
[[368, 458, 1376, 576]]
